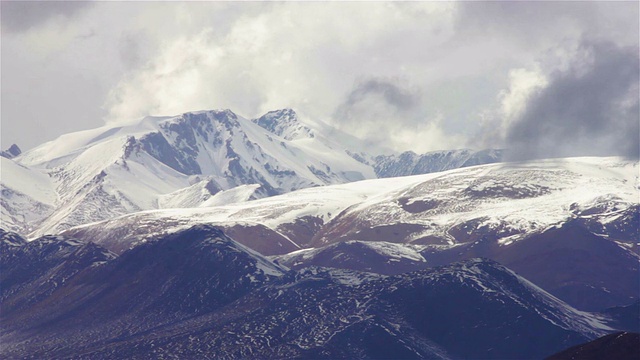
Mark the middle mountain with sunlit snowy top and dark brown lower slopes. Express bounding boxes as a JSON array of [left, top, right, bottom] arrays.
[[61, 158, 640, 310]]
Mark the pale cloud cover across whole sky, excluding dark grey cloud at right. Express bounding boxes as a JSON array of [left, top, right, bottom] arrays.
[[2, 2, 638, 150]]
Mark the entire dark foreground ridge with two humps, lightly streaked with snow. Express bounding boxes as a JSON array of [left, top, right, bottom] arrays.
[[0, 226, 608, 358]]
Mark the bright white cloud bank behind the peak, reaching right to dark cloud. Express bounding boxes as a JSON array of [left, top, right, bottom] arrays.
[[100, 3, 628, 156]]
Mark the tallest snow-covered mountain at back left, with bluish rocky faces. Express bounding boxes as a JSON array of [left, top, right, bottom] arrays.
[[1, 109, 497, 237]]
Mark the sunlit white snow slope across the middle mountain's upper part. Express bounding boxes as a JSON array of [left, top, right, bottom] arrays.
[[67, 157, 638, 253]]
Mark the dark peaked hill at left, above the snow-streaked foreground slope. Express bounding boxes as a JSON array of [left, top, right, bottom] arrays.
[[2, 226, 286, 332]]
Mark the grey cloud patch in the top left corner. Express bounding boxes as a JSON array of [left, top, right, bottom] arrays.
[[0, 1, 93, 33]]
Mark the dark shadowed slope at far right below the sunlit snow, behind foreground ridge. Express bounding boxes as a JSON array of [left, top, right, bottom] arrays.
[[422, 221, 640, 311]]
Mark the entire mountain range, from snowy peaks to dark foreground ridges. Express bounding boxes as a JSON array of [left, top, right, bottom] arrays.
[[0, 109, 640, 359]]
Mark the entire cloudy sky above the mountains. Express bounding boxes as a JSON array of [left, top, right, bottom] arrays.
[[0, 1, 640, 159]]
